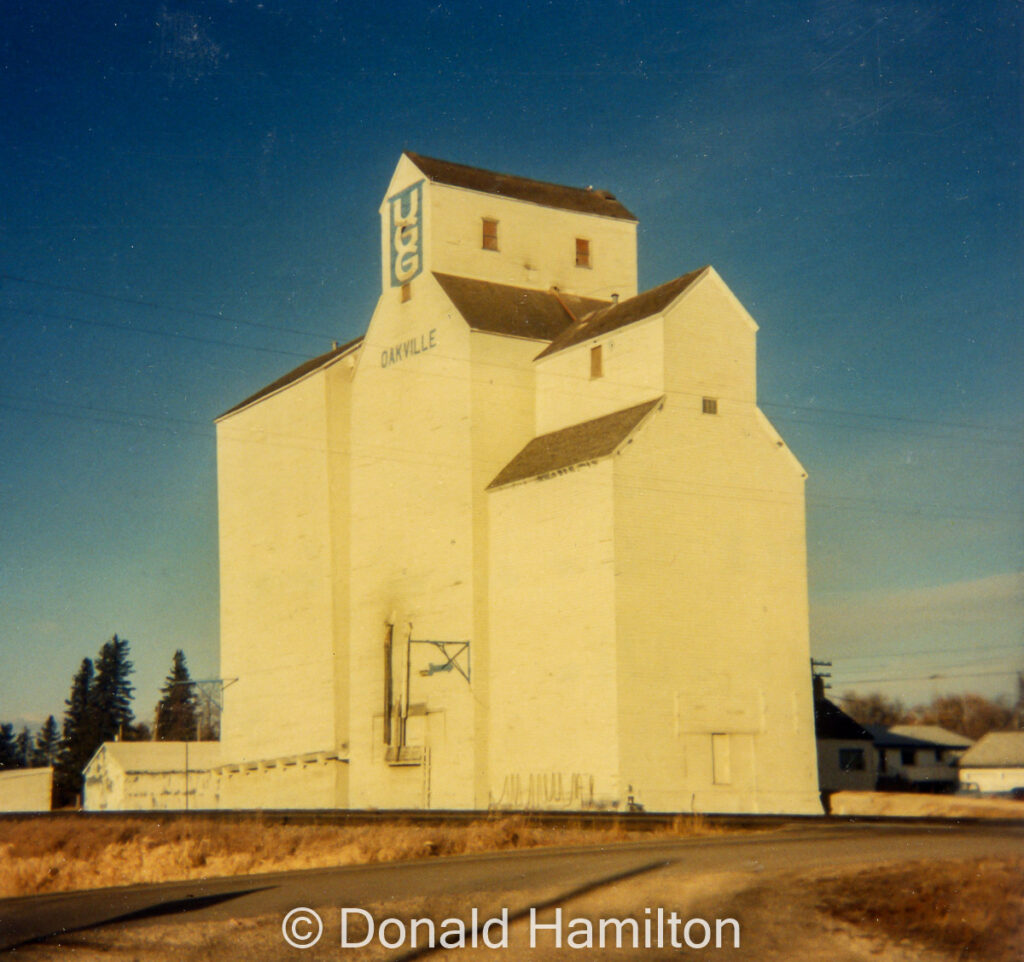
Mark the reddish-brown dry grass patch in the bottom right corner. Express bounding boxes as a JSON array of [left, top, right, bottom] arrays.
[[819, 859, 1024, 962]]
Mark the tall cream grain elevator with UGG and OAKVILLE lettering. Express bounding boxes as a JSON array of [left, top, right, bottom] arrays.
[[90, 153, 821, 813]]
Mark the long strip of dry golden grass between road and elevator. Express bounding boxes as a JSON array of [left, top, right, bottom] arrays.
[[0, 815, 722, 897]]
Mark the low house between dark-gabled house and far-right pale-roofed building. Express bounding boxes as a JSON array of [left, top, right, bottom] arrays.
[[867, 724, 974, 792]]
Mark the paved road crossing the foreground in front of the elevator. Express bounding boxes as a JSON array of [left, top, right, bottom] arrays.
[[0, 823, 1024, 950]]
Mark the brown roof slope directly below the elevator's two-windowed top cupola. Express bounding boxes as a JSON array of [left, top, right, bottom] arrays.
[[434, 273, 608, 341]]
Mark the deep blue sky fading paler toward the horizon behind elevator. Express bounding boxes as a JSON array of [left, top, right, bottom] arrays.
[[0, 0, 1024, 721]]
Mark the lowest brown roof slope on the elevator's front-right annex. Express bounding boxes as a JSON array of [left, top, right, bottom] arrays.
[[487, 398, 665, 490]]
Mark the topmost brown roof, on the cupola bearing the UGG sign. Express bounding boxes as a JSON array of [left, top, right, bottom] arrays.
[[404, 151, 637, 220]]
